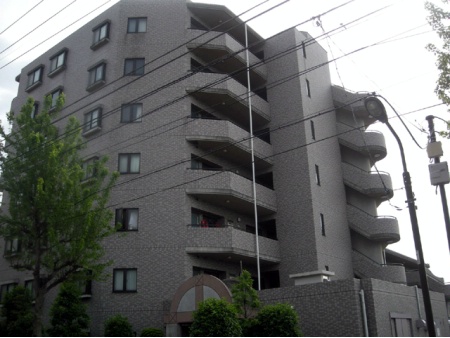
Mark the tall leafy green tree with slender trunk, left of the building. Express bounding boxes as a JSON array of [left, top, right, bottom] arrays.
[[0, 95, 118, 336]]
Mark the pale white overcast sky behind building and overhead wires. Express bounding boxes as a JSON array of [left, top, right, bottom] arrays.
[[0, 0, 450, 283]]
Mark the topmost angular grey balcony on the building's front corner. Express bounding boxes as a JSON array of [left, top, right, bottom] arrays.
[[187, 29, 267, 88]]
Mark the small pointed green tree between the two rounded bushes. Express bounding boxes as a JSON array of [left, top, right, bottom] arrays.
[[231, 270, 261, 318]]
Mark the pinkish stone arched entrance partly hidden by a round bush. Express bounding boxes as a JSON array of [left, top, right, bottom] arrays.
[[164, 274, 231, 337]]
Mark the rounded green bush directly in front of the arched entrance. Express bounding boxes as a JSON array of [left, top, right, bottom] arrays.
[[189, 298, 242, 337]]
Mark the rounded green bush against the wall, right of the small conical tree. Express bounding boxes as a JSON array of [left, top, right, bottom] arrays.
[[254, 304, 302, 337]]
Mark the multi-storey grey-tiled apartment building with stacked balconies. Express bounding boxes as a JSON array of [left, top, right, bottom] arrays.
[[0, 0, 448, 336]]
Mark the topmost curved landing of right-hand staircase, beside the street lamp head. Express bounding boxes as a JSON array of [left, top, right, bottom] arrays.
[[331, 86, 377, 126]]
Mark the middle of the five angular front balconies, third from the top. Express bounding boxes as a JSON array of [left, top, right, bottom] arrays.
[[186, 119, 273, 171]]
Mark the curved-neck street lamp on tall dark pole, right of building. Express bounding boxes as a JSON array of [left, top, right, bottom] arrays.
[[364, 96, 436, 337]]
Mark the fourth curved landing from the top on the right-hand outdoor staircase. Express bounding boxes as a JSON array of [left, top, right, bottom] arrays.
[[347, 204, 400, 244]]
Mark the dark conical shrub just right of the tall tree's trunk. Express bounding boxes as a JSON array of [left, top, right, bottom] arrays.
[[48, 283, 90, 337]]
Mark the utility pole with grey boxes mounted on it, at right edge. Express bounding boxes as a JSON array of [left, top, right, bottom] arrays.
[[426, 115, 450, 250]]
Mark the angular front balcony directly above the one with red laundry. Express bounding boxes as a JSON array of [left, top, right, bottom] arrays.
[[185, 170, 276, 215]]
